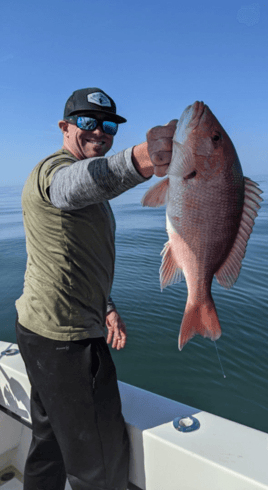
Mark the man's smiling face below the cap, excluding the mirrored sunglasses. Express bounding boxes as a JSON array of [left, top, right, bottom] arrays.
[[59, 112, 113, 160]]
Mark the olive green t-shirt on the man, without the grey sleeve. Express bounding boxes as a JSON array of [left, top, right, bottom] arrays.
[[16, 150, 115, 340]]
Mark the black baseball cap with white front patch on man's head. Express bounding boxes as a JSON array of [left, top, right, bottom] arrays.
[[63, 87, 127, 124]]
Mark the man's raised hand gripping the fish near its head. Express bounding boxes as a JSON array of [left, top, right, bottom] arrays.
[[147, 119, 178, 177]]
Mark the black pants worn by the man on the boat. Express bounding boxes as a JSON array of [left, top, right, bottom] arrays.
[[16, 322, 129, 490]]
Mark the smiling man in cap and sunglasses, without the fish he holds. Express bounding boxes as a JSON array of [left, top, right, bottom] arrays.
[[16, 88, 175, 490]]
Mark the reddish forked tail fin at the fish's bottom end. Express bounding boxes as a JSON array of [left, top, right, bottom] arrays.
[[179, 298, 221, 350]]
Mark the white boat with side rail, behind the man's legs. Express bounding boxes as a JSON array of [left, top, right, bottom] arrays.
[[0, 341, 268, 490]]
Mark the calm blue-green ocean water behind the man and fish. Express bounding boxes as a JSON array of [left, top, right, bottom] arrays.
[[0, 175, 268, 432]]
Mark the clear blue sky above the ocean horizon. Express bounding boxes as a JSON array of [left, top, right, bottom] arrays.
[[0, 0, 268, 185]]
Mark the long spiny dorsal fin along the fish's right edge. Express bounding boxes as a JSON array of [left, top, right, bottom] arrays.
[[215, 177, 262, 289]]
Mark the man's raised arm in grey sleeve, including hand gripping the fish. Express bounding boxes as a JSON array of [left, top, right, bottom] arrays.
[[49, 121, 176, 211]]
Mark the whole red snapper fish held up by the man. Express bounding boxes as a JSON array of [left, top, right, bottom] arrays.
[[142, 101, 262, 350]]
